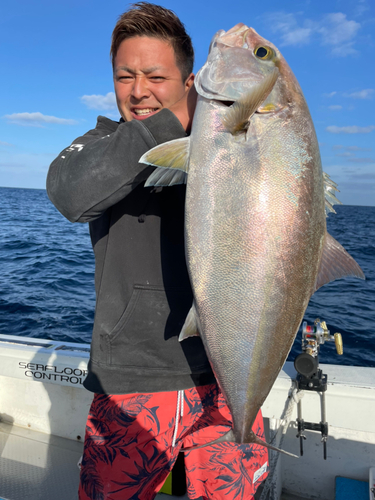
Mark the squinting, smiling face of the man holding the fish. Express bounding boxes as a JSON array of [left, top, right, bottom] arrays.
[[114, 36, 194, 121]]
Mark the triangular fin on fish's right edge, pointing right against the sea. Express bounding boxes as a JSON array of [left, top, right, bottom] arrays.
[[315, 233, 365, 290]]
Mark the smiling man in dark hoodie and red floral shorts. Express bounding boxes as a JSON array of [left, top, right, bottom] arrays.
[[47, 2, 268, 500]]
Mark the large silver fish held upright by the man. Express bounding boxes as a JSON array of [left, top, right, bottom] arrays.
[[140, 24, 364, 454]]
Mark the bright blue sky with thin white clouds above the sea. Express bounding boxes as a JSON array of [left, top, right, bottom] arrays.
[[0, 0, 375, 205]]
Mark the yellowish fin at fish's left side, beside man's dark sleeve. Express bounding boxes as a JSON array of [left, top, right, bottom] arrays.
[[139, 137, 190, 186]]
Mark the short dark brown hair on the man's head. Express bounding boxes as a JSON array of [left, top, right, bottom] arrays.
[[110, 2, 194, 81]]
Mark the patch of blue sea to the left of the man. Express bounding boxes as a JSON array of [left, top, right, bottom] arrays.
[[0, 188, 95, 342]]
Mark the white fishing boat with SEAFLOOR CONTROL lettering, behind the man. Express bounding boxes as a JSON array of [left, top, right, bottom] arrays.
[[0, 335, 375, 500]]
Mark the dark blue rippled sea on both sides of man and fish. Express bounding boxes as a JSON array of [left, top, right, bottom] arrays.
[[0, 188, 375, 367]]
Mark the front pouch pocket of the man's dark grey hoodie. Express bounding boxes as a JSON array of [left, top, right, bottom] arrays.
[[106, 285, 192, 370]]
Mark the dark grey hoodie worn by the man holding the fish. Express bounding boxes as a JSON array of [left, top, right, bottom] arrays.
[[47, 109, 214, 394]]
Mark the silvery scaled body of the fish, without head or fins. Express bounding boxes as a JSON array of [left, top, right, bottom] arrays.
[[186, 45, 326, 443]]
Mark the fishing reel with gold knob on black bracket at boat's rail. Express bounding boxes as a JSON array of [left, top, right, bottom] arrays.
[[294, 318, 343, 460]]
